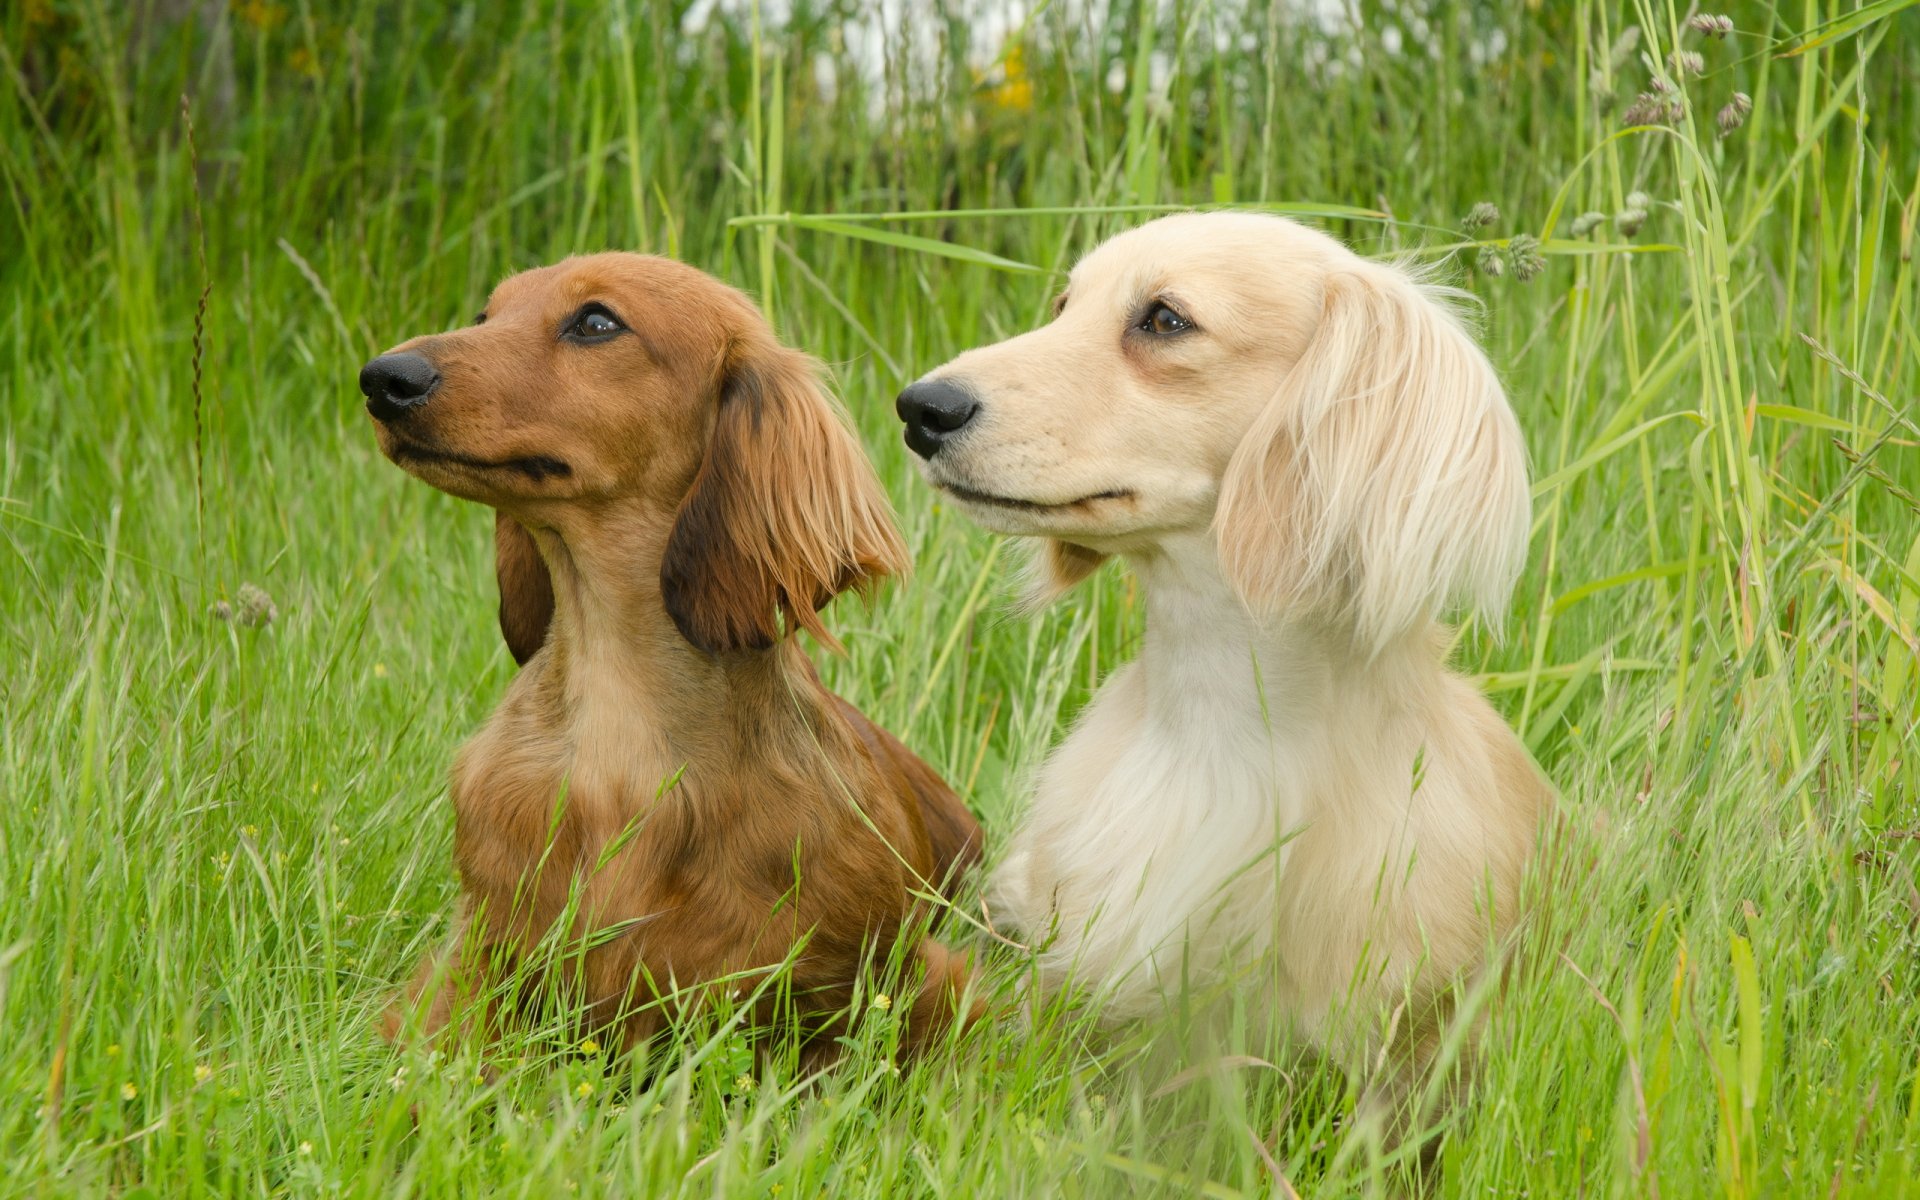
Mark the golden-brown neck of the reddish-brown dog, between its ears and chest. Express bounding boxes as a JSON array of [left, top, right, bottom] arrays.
[[530, 518, 816, 762]]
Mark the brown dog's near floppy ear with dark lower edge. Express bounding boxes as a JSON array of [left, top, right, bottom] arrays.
[[660, 334, 906, 653]]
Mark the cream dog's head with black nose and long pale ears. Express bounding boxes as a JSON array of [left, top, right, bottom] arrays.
[[899, 213, 1528, 647]]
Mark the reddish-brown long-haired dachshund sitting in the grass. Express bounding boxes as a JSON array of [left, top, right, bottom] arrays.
[[361, 253, 979, 1058]]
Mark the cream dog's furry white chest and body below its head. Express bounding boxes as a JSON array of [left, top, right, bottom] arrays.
[[995, 540, 1530, 1035]]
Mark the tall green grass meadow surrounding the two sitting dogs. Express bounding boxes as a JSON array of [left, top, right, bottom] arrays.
[[0, 0, 1920, 1200]]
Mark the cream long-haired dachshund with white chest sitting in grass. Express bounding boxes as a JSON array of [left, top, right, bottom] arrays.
[[899, 213, 1549, 1121]]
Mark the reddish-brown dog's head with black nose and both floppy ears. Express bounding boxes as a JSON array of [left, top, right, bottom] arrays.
[[359, 253, 906, 662]]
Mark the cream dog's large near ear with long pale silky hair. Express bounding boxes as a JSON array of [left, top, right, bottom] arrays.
[[1213, 263, 1532, 653]]
